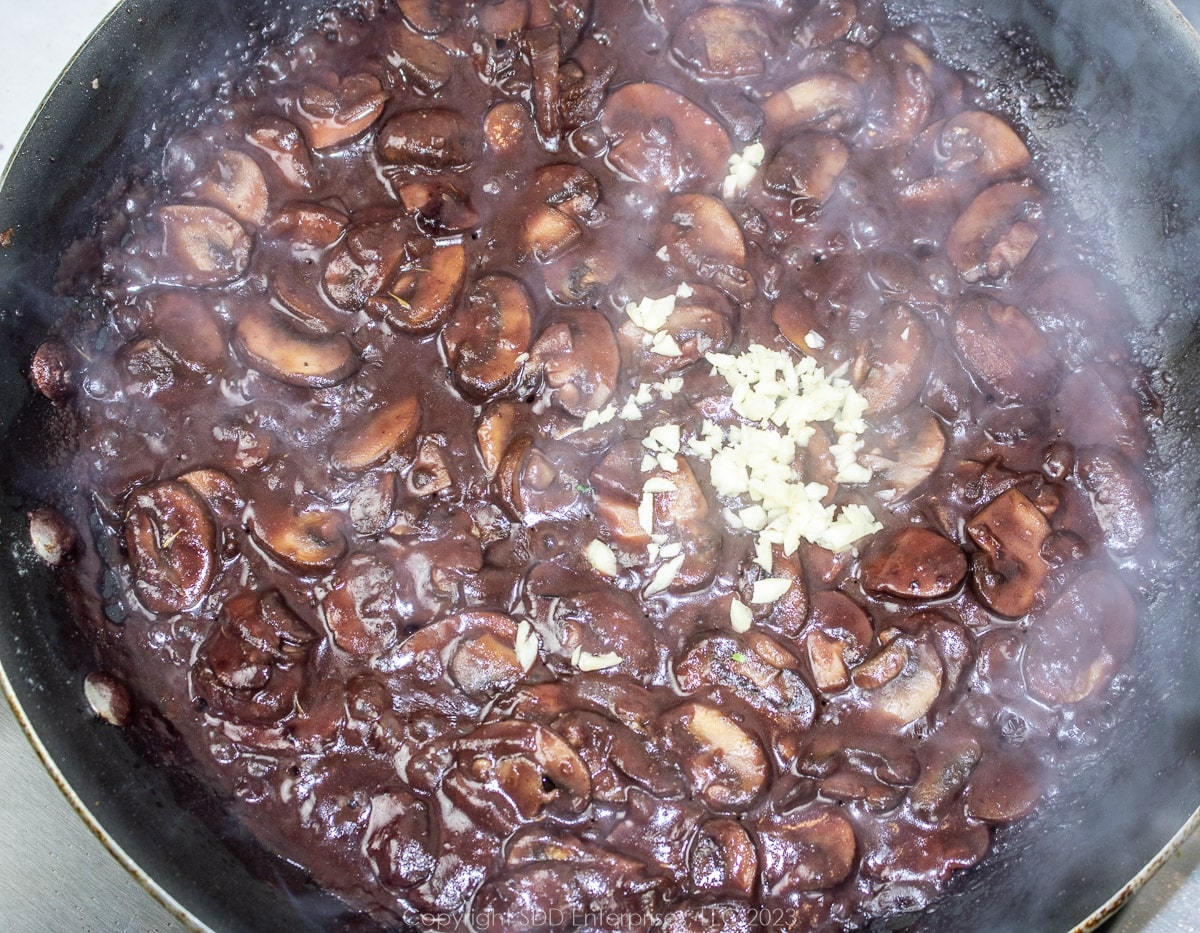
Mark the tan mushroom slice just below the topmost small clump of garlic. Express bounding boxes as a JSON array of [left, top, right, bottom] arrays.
[[658, 194, 758, 301]]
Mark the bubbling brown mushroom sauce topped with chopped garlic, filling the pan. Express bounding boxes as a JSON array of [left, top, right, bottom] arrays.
[[32, 0, 1152, 931]]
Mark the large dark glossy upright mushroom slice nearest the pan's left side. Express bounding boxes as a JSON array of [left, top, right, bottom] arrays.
[[125, 482, 217, 613]]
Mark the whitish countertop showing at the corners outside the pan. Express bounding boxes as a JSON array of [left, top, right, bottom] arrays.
[[0, 0, 1200, 933]]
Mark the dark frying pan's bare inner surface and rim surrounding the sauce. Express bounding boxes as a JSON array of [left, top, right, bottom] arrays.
[[0, 0, 1200, 932]]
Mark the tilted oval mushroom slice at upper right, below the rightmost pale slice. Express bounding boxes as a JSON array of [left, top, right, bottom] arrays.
[[946, 181, 1044, 282]]
